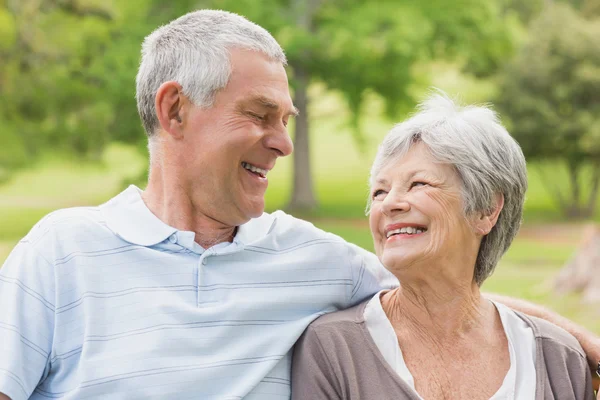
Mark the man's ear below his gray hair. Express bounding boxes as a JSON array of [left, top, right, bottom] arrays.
[[154, 81, 185, 138]]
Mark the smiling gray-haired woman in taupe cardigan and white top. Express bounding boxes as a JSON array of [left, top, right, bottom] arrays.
[[292, 94, 593, 400]]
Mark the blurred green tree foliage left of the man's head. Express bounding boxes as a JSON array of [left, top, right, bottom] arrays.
[[0, 0, 192, 180]]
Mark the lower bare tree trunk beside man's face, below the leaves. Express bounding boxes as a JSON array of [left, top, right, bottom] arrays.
[[288, 66, 317, 210]]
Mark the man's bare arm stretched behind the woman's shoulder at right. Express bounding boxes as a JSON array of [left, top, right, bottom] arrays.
[[485, 293, 600, 390]]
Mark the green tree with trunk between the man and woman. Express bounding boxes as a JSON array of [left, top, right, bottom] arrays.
[[206, 0, 512, 209]]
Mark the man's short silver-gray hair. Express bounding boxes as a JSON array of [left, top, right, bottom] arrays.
[[136, 10, 287, 137]]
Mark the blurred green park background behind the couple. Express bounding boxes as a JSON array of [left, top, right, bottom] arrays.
[[0, 0, 600, 333]]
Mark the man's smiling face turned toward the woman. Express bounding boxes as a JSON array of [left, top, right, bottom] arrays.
[[181, 49, 296, 226]]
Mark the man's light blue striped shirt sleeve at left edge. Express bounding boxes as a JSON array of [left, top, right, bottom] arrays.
[[0, 239, 55, 400]]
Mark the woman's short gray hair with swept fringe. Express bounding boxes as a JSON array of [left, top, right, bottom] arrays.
[[367, 92, 527, 286]]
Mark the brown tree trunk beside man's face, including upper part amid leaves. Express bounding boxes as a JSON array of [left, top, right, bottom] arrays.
[[287, 0, 319, 211]]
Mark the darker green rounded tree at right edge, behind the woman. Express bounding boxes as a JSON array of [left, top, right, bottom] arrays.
[[497, 3, 600, 217]]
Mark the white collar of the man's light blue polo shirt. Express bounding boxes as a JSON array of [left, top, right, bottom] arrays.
[[100, 185, 277, 247]]
